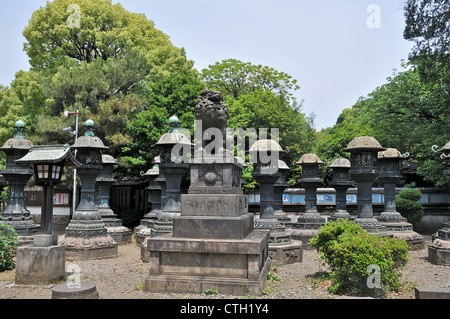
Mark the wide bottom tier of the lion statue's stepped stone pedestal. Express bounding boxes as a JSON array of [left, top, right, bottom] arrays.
[[145, 230, 270, 295]]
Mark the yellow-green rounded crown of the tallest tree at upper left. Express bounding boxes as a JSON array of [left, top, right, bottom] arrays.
[[23, 0, 185, 76]]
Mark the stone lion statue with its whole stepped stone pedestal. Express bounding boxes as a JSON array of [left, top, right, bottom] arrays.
[[145, 90, 270, 295]]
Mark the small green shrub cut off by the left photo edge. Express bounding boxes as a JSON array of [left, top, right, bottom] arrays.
[[0, 222, 19, 271]]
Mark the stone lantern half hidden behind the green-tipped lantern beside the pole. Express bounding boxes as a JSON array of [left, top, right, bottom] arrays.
[[95, 154, 132, 244]]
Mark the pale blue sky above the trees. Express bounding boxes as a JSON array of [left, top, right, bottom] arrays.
[[0, 0, 412, 129]]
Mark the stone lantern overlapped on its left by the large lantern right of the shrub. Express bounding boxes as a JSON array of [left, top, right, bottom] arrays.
[[378, 148, 424, 250]]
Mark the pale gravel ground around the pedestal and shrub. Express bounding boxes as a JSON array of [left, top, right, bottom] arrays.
[[0, 235, 450, 299]]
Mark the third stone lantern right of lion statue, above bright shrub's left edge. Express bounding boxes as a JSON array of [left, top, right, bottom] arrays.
[[292, 154, 326, 249]]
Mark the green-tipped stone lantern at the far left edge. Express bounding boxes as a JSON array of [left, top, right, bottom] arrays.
[[0, 120, 41, 245]]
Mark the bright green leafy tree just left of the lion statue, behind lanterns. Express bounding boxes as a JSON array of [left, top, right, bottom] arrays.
[[122, 65, 205, 176]]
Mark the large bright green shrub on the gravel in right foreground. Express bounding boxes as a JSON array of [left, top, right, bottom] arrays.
[[309, 221, 408, 295]]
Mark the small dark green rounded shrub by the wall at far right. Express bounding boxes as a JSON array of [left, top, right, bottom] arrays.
[[395, 189, 424, 230]]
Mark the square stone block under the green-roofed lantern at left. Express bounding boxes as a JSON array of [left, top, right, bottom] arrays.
[[15, 245, 66, 285]]
